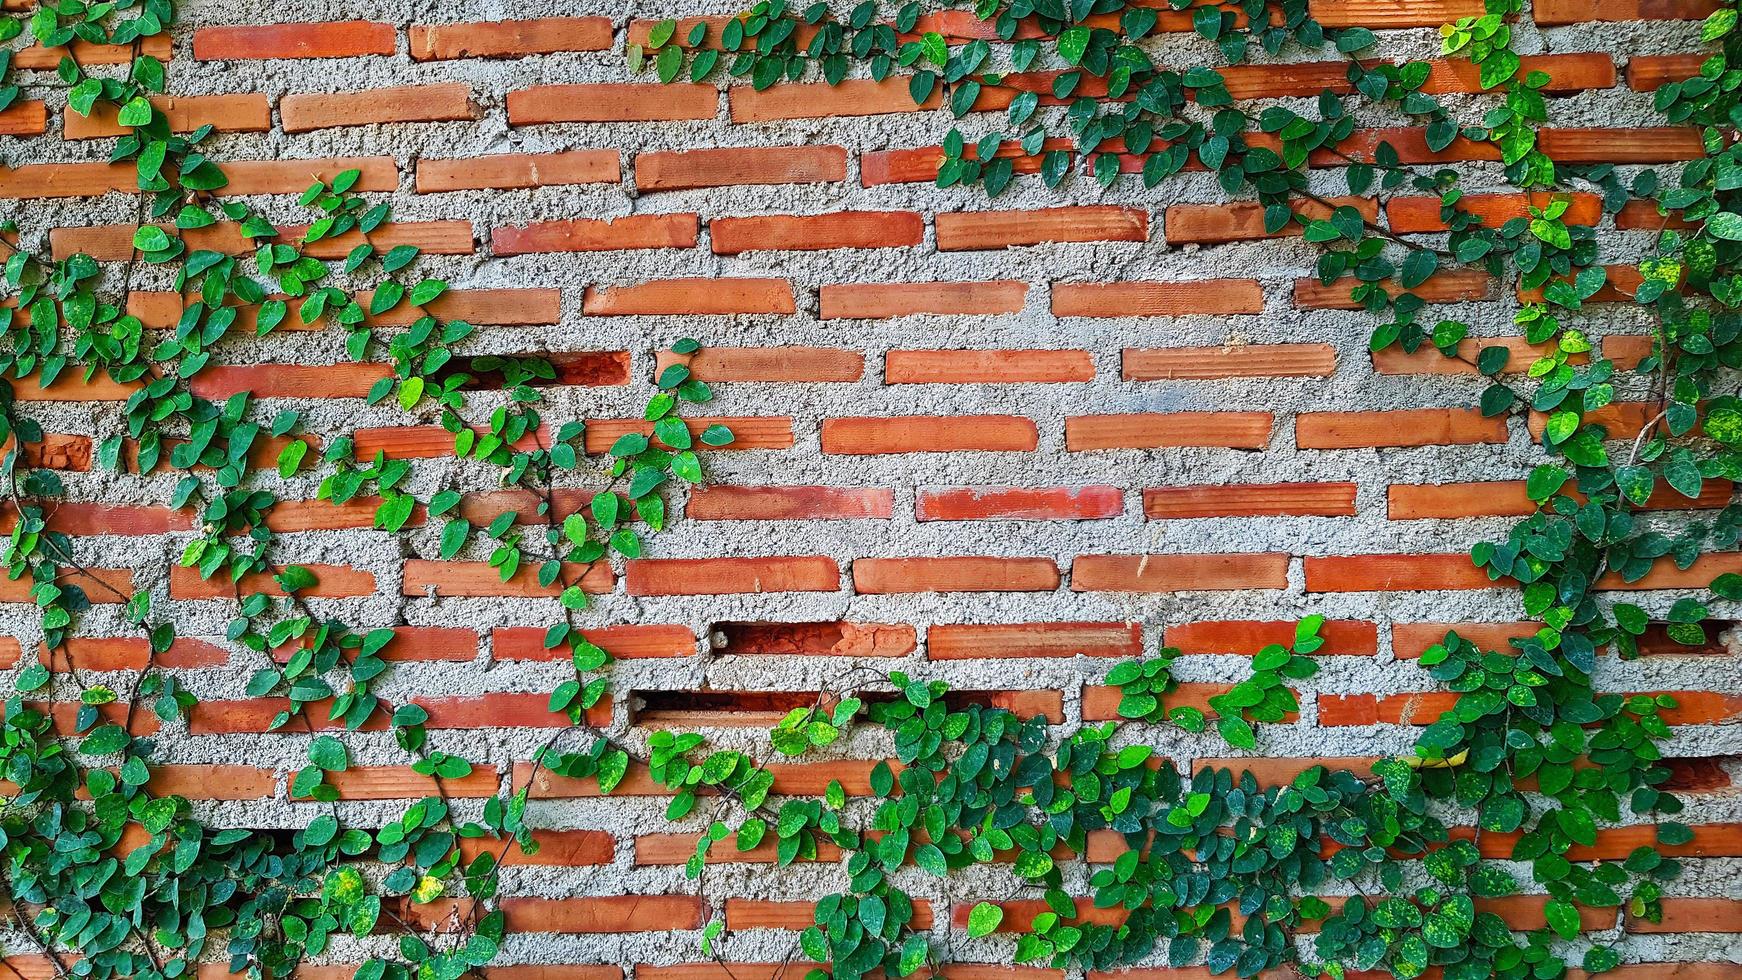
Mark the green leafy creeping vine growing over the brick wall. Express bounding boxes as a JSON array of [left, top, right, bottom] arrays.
[[0, 0, 1742, 980]]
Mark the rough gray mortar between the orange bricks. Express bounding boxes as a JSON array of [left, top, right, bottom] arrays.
[[0, 0, 1742, 966]]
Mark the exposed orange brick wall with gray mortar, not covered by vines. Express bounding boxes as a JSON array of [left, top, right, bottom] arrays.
[[0, 0, 1742, 980]]
